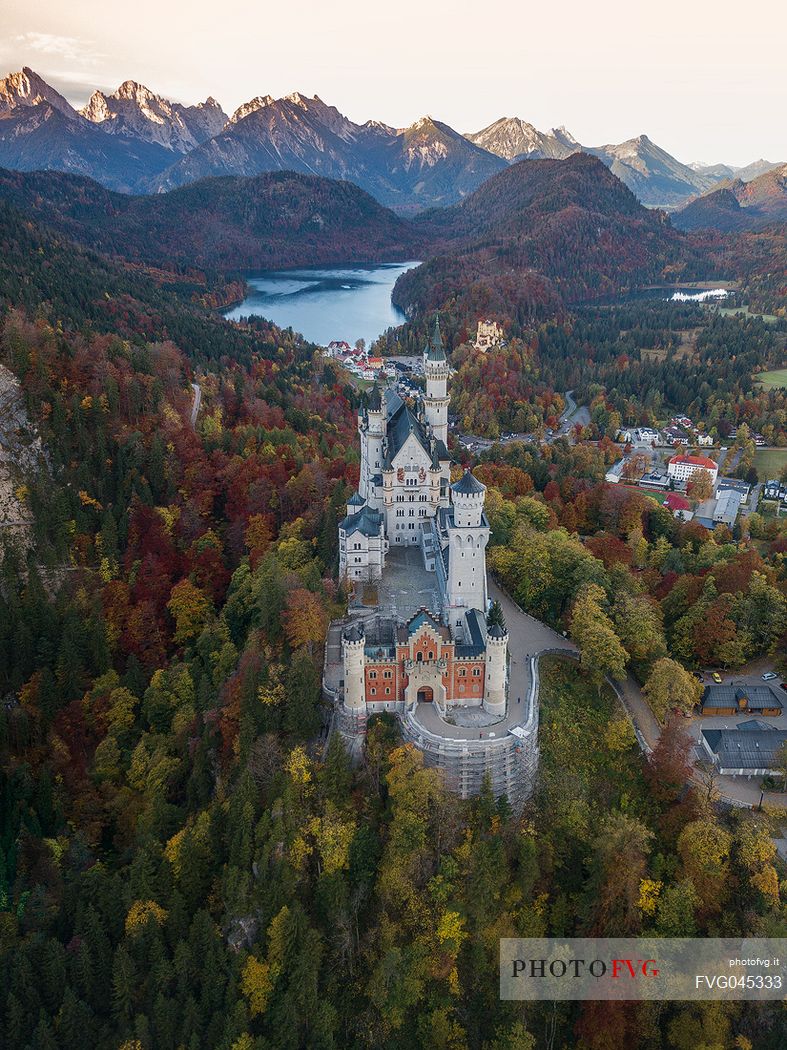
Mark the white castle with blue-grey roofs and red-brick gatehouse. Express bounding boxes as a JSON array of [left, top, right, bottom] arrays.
[[339, 320, 508, 714]]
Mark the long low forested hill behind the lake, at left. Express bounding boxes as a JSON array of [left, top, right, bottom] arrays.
[[0, 169, 420, 273]]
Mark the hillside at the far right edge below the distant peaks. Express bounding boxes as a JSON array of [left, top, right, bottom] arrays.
[[673, 164, 787, 232]]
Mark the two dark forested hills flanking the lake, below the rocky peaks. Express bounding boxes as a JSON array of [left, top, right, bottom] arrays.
[[0, 153, 709, 326]]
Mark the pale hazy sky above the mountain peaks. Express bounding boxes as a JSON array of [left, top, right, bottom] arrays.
[[0, 0, 787, 164]]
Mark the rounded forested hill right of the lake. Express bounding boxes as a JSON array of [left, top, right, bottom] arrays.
[[394, 153, 704, 323]]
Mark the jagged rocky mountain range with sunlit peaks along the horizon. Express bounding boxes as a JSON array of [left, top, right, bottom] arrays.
[[0, 67, 775, 213]]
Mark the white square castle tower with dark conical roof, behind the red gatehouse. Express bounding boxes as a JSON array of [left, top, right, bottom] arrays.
[[446, 470, 489, 638]]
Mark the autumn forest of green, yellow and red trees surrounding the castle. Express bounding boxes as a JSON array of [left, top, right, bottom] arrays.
[[0, 176, 787, 1050]]
